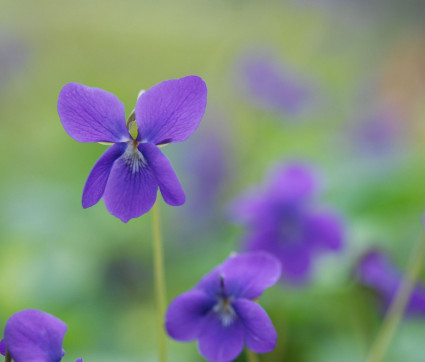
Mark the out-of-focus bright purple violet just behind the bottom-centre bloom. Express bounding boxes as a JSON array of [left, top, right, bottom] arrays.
[[231, 164, 343, 284]]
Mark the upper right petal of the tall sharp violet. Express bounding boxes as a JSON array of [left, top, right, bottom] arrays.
[[136, 75, 207, 145]]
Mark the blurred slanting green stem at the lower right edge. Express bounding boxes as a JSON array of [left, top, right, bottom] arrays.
[[366, 238, 425, 362]]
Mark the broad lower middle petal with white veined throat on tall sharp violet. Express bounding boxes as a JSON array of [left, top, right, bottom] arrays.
[[103, 151, 158, 222]]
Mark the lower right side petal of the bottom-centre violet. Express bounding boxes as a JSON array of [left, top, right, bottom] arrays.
[[232, 299, 277, 353]]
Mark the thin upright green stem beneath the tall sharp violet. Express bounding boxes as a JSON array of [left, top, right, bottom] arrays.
[[152, 202, 167, 362]]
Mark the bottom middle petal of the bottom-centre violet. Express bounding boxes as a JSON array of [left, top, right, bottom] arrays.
[[198, 313, 244, 362]]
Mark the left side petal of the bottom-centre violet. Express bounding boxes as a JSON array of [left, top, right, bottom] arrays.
[[165, 290, 215, 342]]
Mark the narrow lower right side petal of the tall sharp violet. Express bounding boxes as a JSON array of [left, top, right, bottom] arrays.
[[139, 143, 186, 206]]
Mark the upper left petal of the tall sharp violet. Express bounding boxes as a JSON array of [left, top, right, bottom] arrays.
[[58, 83, 130, 142]]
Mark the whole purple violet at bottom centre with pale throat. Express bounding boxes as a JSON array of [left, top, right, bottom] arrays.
[[165, 253, 280, 362]]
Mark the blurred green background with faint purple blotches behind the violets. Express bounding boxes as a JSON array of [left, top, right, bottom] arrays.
[[0, 0, 425, 362]]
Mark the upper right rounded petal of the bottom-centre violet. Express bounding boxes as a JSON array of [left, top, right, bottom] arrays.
[[221, 251, 281, 299]]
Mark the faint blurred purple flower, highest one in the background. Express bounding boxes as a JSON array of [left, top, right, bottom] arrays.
[[237, 52, 312, 116]]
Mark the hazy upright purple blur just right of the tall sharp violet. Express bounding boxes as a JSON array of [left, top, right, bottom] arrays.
[[166, 111, 233, 236]]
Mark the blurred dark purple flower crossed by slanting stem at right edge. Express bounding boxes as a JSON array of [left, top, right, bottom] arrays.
[[356, 250, 425, 317]]
